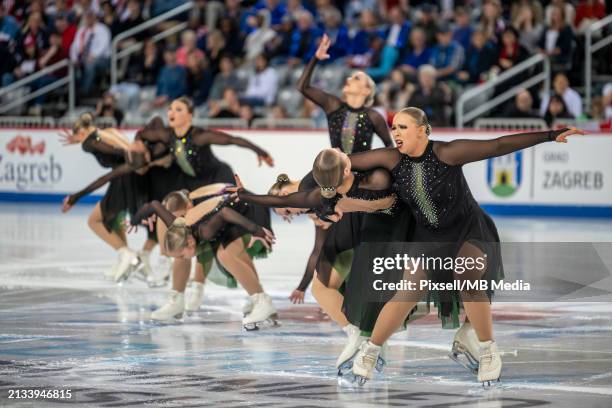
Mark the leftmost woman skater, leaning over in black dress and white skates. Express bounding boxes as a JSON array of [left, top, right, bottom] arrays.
[[61, 113, 155, 282]]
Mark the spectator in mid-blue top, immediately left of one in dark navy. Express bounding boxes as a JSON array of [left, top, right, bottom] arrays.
[[428, 23, 465, 82]]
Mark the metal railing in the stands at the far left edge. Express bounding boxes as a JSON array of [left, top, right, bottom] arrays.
[[0, 59, 75, 114]]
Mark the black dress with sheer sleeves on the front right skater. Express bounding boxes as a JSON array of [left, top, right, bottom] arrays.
[[350, 129, 566, 327]]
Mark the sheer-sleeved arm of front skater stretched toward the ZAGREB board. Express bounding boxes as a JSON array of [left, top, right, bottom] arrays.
[[435, 128, 585, 166]]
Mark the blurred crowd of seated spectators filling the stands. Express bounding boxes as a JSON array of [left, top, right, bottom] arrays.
[[0, 0, 612, 126]]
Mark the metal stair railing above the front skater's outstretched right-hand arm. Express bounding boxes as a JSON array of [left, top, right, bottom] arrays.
[[455, 54, 550, 129]]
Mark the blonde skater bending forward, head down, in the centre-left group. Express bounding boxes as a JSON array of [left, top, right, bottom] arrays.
[[132, 195, 276, 330]]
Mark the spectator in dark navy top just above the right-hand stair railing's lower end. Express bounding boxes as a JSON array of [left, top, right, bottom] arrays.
[[457, 30, 496, 85]]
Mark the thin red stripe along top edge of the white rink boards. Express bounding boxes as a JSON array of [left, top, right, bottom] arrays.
[[0, 127, 612, 137]]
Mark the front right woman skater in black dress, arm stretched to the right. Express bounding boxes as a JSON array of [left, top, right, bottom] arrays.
[[342, 108, 584, 383]]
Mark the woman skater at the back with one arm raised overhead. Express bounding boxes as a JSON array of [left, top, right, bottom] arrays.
[[298, 35, 393, 153]]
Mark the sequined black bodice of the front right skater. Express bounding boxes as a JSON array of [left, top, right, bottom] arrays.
[[391, 141, 478, 229]]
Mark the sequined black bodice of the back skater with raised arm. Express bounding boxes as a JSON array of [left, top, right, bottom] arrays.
[[327, 103, 374, 154]]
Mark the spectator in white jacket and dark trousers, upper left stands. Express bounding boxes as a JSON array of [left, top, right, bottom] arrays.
[[70, 10, 111, 95]]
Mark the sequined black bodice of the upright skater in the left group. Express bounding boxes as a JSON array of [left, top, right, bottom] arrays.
[[168, 127, 219, 177]]
